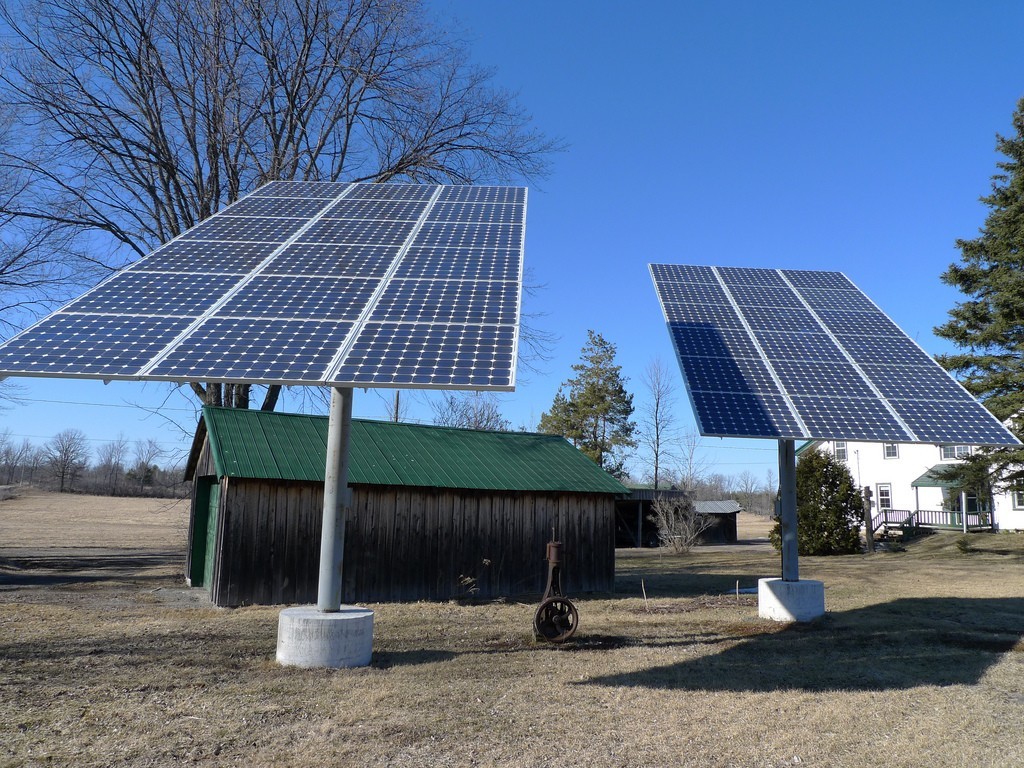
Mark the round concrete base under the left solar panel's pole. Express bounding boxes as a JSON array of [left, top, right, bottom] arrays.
[[278, 605, 374, 669]]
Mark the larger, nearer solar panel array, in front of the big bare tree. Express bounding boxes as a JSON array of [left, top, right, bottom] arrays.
[[0, 181, 526, 389]]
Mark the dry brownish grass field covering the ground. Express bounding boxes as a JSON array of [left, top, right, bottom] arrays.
[[0, 496, 1024, 768]]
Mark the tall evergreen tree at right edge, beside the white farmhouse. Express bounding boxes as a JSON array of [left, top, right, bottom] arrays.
[[935, 98, 1024, 492]]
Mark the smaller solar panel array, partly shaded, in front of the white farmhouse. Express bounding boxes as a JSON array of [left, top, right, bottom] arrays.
[[650, 264, 1018, 445]]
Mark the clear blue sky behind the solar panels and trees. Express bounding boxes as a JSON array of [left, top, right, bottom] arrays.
[[0, 0, 1024, 487]]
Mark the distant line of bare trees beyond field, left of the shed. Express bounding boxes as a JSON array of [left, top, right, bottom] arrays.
[[0, 429, 190, 498]]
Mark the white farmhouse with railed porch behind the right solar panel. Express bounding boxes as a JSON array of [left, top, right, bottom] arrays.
[[797, 440, 1024, 530]]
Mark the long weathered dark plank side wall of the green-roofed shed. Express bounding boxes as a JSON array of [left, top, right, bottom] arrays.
[[203, 478, 614, 605]]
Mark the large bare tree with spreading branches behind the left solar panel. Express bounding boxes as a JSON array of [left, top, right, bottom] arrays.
[[0, 0, 559, 408]]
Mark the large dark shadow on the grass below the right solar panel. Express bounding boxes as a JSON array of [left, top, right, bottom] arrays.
[[579, 598, 1024, 692]]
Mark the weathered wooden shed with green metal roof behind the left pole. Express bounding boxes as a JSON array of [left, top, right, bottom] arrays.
[[185, 407, 629, 606]]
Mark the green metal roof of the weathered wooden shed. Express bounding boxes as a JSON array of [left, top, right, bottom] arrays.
[[185, 406, 629, 494]]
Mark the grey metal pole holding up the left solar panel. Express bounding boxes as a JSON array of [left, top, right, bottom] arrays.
[[316, 387, 352, 612]]
